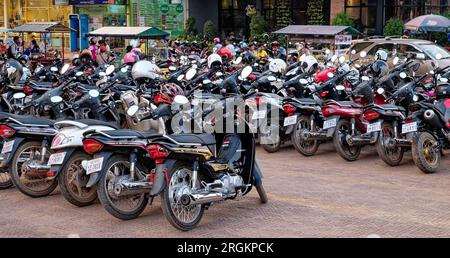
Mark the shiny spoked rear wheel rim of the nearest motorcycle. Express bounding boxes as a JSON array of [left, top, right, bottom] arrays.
[[169, 168, 201, 224]]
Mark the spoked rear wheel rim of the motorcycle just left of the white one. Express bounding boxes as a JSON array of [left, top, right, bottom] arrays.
[[15, 146, 55, 192]]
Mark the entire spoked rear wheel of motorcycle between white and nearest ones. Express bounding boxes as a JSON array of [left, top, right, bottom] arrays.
[[97, 155, 148, 220]]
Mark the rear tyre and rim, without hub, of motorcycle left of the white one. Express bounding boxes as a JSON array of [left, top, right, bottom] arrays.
[[10, 142, 58, 198]]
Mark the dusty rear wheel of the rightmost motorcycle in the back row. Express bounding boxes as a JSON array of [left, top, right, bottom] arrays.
[[411, 132, 441, 174]]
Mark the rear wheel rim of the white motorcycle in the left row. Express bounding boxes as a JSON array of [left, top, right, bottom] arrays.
[[66, 158, 97, 202]]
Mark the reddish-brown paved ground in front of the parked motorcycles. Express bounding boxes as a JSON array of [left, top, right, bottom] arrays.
[[0, 145, 450, 238]]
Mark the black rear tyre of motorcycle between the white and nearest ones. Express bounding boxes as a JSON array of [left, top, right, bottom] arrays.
[[97, 155, 148, 220]]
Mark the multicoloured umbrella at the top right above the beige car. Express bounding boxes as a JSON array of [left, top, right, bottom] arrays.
[[405, 14, 450, 33]]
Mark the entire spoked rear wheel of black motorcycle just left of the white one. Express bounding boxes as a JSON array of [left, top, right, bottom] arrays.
[[10, 142, 58, 197]]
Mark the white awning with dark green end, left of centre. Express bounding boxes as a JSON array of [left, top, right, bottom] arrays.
[[89, 27, 170, 39]]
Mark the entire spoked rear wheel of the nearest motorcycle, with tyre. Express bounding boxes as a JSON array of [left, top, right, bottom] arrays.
[[161, 163, 204, 231]]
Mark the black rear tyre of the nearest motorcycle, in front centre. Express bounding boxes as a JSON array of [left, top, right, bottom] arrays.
[[161, 162, 205, 231]]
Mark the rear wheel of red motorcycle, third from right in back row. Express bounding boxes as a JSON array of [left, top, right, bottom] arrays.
[[333, 119, 361, 161]]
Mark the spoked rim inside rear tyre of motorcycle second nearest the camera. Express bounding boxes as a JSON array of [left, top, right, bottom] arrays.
[[105, 161, 145, 213]]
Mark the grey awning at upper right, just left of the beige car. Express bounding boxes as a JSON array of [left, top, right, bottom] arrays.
[[273, 25, 361, 37]]
